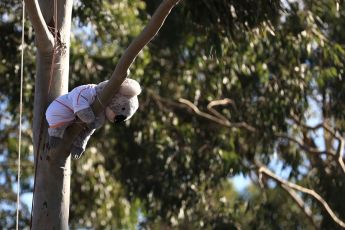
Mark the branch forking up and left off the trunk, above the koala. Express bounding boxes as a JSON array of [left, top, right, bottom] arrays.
[[24, 0, 54, 52]]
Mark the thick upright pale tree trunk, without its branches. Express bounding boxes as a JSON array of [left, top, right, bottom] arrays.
[[32, 0, 72, 229]]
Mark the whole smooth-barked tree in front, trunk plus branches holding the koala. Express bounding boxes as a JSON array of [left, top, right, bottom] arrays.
[[25, 0, 179, 229]]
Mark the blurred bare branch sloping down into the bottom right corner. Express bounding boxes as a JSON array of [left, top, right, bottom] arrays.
[[259, 165, 345, 228]]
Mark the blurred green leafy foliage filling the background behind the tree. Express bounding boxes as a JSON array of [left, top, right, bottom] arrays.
[[0, 0, 345, 229]]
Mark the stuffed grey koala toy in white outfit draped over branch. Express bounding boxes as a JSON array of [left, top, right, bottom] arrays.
[[46, 78, 141, 159]]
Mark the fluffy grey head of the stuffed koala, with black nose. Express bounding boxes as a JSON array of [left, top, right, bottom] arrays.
[[96, 78, 141, 123]]
